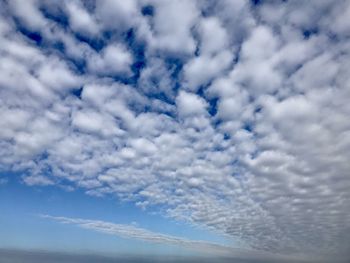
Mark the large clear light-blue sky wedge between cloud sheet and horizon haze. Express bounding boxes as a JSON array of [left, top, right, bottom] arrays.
[[0, 173, 232, 254]]
